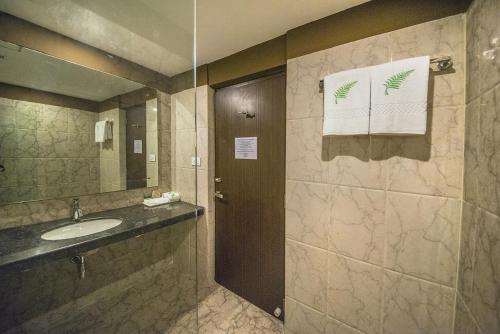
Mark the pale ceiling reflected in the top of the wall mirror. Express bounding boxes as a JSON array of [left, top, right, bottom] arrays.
[[0, 42, 144, 102]]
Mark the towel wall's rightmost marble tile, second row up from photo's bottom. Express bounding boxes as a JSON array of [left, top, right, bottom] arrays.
[[385, 192, 460, 286]]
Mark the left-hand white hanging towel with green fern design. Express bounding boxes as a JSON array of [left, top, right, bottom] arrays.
[[323, 68, 370, 136]]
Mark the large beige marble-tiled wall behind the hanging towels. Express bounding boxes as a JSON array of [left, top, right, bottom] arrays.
[[285, 15, 465, 334]]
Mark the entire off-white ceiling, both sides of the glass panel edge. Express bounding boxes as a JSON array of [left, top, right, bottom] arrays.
[[0, 0, 368, 76]]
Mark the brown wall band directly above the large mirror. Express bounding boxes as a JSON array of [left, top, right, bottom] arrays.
[[0, 12, 170, 92]]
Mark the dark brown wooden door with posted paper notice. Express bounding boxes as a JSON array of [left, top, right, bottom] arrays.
[[215, 73, 286, 318]]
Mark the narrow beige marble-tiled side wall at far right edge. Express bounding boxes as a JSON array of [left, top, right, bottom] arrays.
[[455, 0, 500, 334]]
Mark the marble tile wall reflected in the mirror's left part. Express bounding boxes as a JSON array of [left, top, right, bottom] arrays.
[[0, 98, 99, 205]]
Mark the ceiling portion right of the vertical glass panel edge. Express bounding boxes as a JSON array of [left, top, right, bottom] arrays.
[[197, 0, 367, 64]]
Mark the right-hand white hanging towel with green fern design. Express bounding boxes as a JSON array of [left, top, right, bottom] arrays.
[[370, 56, 429, 135]]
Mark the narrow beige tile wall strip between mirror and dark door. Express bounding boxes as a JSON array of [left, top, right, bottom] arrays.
[[172, 85, 215, 299]]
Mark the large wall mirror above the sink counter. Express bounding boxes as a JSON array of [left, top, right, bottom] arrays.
[[0, 41, 158, 205]]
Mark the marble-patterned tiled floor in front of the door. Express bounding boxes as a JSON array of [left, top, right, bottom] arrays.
[[170, 287, 283, 334]]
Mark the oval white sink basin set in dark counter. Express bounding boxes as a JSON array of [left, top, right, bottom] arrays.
[[42, 218, 122, 240]]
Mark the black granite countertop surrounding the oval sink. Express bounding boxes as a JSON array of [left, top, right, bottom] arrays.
[[0, 202, 203, 269]]
